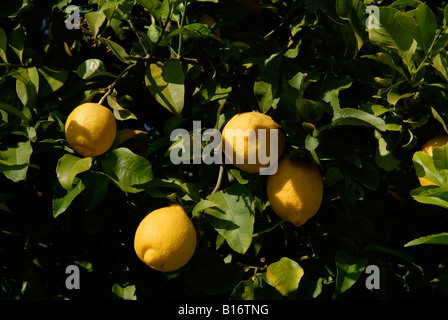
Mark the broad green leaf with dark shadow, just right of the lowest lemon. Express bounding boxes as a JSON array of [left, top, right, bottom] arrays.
[[204, 184, 255, 254]]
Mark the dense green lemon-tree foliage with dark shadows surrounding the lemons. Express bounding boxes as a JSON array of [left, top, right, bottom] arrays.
[[0, 0, 448, 300]]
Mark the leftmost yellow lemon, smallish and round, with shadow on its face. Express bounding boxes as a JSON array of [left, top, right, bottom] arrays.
[[65, 103, 117, 157]]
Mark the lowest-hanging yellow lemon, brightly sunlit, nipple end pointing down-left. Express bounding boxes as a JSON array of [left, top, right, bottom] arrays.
[[134, 204, 197, 272]]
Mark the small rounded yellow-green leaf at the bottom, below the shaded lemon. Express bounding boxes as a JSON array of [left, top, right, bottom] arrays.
[[266, 257, 304, 296]]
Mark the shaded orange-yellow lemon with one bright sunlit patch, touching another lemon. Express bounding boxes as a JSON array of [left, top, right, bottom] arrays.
[[266, 157, 323, 227]]
